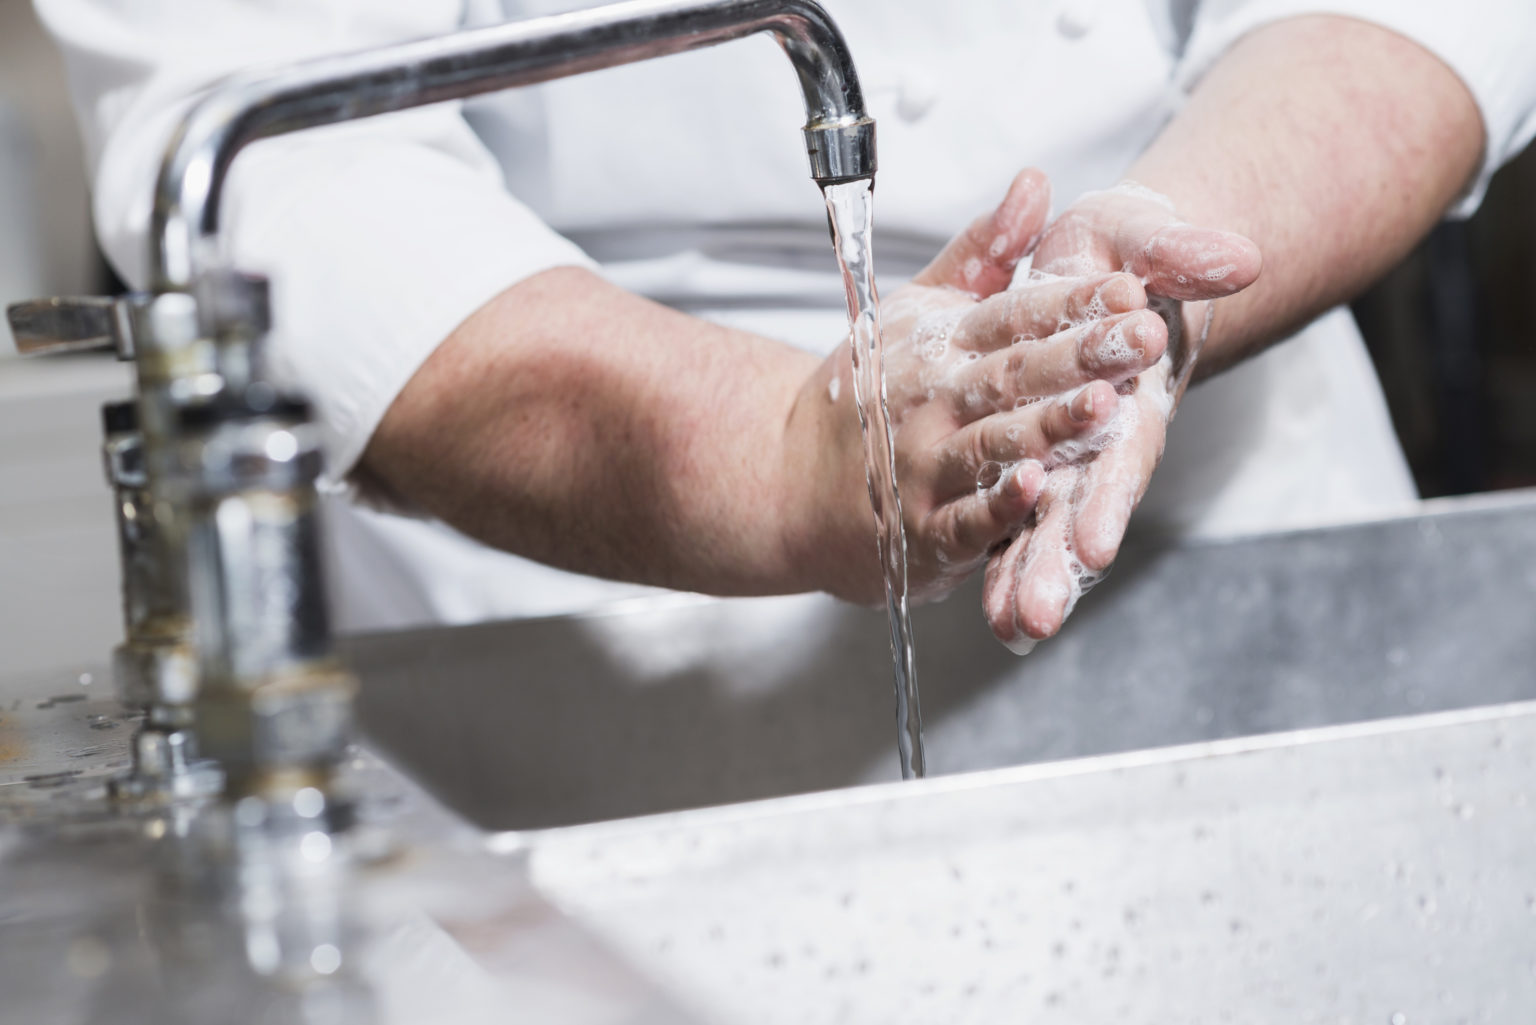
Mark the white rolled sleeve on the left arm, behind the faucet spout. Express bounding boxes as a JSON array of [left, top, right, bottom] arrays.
[[35, 0, 593, 479]]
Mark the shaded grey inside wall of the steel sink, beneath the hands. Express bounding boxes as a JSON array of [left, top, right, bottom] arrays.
[[350, 492, 1536, 830]]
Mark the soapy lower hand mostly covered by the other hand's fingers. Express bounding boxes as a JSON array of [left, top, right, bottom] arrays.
[[983, 184, 1261, 652]]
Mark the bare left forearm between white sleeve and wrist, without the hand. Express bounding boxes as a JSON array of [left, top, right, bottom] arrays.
[[362, 267, 874, 593]]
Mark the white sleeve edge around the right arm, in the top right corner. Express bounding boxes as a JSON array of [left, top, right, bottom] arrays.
[[1177, 0, 1536, 217]]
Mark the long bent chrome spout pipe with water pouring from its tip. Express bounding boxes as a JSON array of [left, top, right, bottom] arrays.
[[151, 0, 876, 292]]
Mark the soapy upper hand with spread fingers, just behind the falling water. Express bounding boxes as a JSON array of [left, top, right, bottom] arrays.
[[797, 171, 1167, 602]]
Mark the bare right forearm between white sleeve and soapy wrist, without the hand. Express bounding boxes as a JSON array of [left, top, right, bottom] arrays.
[[1127, 15, 1484, 375]]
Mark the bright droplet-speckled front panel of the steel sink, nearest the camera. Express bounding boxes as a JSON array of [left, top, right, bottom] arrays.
[[513, 702, 1536, 1025]]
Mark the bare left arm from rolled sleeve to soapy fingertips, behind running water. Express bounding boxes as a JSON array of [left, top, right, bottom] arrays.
[[362, 172, 1166, 601]]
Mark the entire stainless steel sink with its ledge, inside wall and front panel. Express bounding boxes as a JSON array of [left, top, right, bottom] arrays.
[[0, 495, 1536, 1025]]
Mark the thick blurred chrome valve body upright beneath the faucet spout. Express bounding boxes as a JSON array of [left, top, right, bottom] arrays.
[[166, 384, 355, 799]]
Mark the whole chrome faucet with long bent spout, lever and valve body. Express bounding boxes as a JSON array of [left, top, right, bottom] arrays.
[[9, 0, 876, 818]]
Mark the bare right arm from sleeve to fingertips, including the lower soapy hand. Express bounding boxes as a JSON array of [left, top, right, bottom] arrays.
[[985, 15, 1484, 642]]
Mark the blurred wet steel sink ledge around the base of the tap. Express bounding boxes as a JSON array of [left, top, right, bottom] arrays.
[[0, 668, 696, 1025]]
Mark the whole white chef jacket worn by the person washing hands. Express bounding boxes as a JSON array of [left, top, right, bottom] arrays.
[[35, 0, 1536, 629]]
